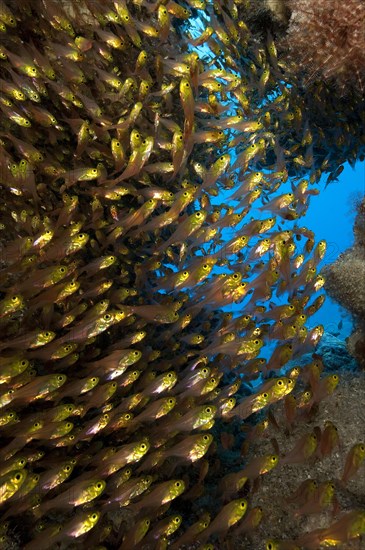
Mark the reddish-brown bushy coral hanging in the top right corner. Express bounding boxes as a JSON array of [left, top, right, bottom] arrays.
[[287, 0, 365, 95]]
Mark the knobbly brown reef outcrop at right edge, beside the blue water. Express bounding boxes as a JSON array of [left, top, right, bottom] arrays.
[[323, 198, 365, 367]]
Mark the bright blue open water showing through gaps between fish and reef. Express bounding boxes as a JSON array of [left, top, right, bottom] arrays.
[[171, 14, 365, 355]]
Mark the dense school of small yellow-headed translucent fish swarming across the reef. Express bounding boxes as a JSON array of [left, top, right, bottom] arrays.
[[0, 0, 365, 550]]
